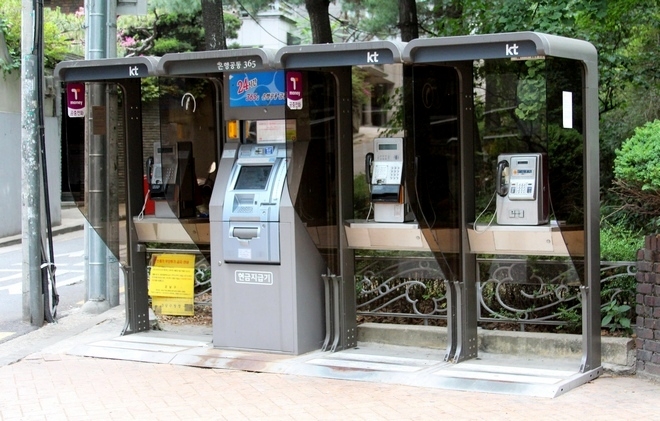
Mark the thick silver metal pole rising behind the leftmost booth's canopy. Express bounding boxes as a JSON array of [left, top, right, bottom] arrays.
[[82, 0, 110, 313]]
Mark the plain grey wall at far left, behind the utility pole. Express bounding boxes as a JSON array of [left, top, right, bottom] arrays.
[[0, 70, 62, 237]]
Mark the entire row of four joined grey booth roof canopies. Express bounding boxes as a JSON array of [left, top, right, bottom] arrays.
[[55, 32, 597, 82]]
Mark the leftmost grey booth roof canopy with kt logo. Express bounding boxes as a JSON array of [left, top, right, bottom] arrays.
[[53, 57, 160, 82]]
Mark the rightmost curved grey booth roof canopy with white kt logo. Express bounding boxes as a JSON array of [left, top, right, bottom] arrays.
[[403, 32, 597, 63]]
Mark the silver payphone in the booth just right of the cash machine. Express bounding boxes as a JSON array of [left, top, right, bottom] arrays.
[[365, 137, 406, 222]]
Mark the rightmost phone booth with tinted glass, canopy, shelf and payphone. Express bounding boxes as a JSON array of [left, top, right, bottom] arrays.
[[403, 32, 602, 380]]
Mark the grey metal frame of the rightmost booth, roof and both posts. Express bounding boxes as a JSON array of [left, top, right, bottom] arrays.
[[403, 32, 602, 374]]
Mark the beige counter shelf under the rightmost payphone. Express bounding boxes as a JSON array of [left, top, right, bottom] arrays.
[[468, 221, 584, 256]]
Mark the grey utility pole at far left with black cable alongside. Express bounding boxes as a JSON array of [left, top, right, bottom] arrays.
[[21, 0, 44, 326]]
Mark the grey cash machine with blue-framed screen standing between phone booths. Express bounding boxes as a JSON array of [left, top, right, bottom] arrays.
[[209, 71, 327, 355]]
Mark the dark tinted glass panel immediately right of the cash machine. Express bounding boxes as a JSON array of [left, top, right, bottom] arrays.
[[287, 72, 340, 274]]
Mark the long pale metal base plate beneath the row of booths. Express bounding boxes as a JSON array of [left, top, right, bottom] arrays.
[[70, 331, 603, 398]]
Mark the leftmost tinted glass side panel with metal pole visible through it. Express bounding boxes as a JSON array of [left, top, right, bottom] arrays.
[[62, 83, 126, 264]]
